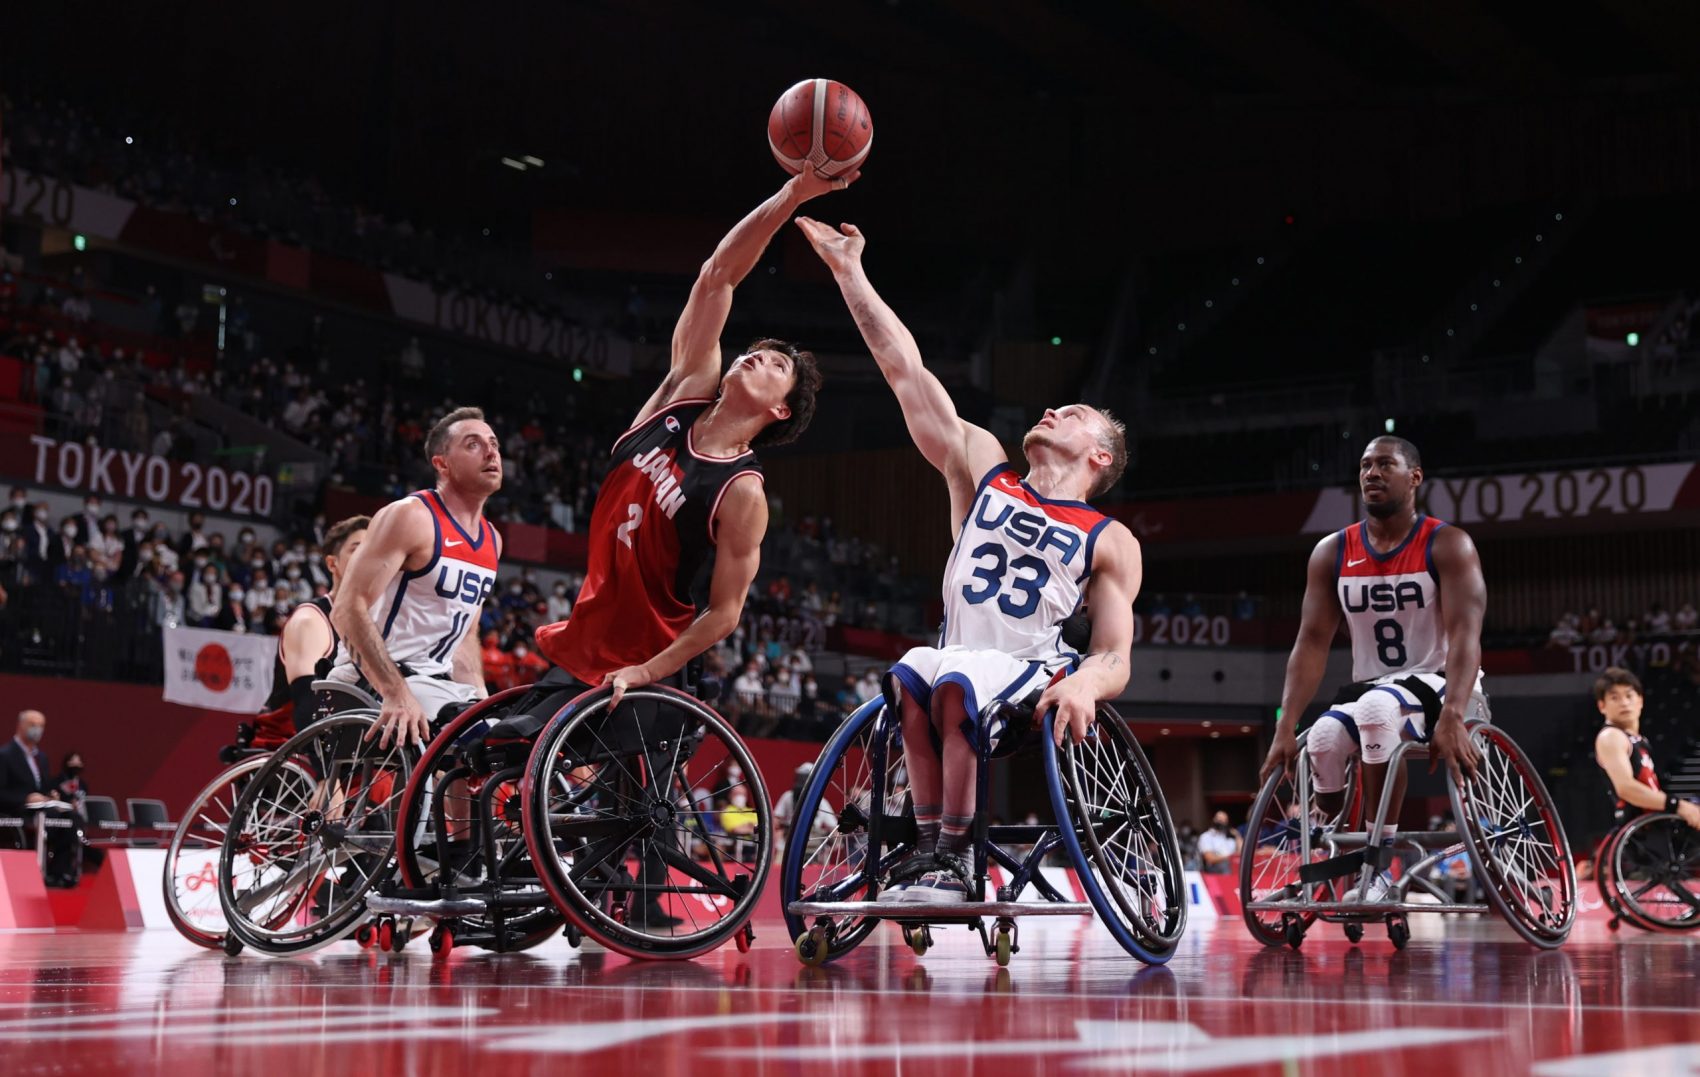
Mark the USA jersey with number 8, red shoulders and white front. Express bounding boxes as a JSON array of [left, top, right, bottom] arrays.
[[1335, 515, 1447, 681]]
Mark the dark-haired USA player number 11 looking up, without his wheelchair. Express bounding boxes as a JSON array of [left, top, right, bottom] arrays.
[[332, 408, 502, 747]]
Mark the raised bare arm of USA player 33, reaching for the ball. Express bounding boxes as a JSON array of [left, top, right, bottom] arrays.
[[797, 217, 1008, 533]]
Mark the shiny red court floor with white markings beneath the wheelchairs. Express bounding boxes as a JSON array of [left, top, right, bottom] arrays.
[[0, 917, 1700, 1077]]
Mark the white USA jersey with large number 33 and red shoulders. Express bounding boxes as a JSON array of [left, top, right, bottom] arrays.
[[938, 464, 1110, 661]]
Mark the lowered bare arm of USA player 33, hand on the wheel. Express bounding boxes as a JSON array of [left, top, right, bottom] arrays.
[[1034, 522, 1144, 744]]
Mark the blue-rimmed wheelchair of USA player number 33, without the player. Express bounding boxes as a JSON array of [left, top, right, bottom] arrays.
[[780, 679, 1187, 967]]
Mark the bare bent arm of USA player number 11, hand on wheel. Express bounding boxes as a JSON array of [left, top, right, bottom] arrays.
[[330, 498, 437, 747]]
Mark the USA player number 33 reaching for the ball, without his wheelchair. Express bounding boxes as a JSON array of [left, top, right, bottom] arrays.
[[797, 217, 1141, 902]]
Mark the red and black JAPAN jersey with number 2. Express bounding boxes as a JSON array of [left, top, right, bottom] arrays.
[[537, 399, 762, 685]]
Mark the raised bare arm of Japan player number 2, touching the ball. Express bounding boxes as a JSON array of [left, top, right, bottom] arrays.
[[632, 168, 862, 425]]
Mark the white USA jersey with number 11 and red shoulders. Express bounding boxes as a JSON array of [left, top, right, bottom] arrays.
[[351, 489, 500, 676]]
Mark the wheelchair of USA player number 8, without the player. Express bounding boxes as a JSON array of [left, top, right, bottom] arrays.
[[1239, 698, 1576, 950]]
